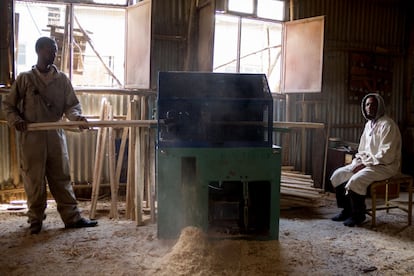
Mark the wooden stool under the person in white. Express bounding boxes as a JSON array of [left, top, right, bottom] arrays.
[[367, 174, 413, 227]]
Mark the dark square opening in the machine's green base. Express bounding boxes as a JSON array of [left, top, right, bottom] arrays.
[[208, 181, 271, 236]]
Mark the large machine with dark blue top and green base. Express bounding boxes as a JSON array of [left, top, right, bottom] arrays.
[[156, 72, 281, 239]]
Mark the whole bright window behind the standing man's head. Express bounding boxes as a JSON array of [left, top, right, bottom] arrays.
[[15, 1, 125, 87]]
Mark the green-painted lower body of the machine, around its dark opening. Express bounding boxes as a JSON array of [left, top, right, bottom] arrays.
[[158, 147, 281, 239]]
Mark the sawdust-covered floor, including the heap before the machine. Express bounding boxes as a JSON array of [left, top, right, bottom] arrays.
[[0, 197, 414, 275]]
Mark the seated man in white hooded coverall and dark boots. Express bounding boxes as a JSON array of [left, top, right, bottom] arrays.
[[331, 94, 401, 227]]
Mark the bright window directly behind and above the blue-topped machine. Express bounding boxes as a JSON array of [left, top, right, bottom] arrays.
[[213, 0, 284, 92]]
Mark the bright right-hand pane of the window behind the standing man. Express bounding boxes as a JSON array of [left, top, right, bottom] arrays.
[[72, 6, 125, 87]]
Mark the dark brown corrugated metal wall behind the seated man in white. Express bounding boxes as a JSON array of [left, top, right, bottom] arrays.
[[287, 0, 408, 180]]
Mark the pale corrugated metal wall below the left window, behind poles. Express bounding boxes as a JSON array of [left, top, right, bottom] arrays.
[[0, 91, 156, 190]]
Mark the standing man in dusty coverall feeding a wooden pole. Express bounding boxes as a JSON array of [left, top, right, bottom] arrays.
[[3, 37, 97, 234]]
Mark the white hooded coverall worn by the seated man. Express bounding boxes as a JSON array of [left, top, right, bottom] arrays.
[[330, 93, 401, 195]]
